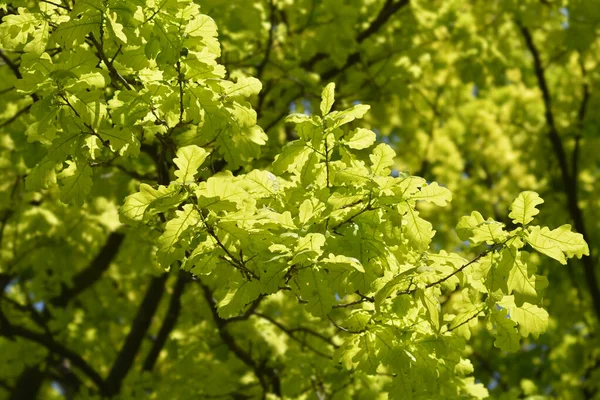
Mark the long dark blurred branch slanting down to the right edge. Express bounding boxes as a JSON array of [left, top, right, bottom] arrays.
[[517, 21, 600, 320]]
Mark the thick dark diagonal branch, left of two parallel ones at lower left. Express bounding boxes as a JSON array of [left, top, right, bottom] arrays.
[[104, 273, 168, 397]]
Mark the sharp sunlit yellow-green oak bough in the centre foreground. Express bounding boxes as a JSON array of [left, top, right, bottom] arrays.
[[121, 84, 587, 398]]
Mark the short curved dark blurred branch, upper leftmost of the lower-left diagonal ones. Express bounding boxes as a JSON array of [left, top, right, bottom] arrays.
[[50, 232, 125, 307]]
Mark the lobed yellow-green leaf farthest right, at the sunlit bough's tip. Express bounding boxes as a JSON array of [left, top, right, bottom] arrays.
[[525, 224, 590, 264]]
